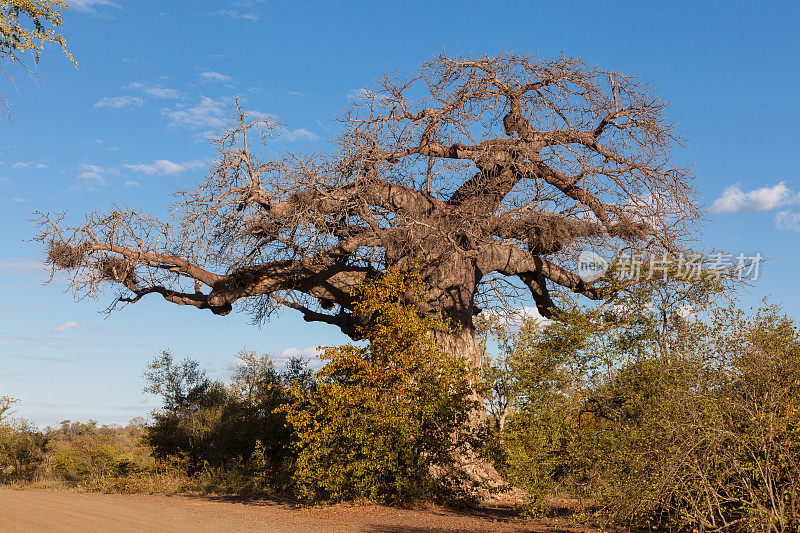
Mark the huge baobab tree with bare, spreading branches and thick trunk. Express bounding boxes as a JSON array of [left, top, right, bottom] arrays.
[[37, 54, 700, 374]]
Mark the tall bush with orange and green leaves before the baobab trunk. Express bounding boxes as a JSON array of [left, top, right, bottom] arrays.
[[285, 270, 476, 502]]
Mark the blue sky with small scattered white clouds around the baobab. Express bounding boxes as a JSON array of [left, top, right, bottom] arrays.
[[0, 0, 800, 424]]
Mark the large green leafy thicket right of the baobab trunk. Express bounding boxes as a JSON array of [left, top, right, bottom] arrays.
[[486, 280, 800, 531]]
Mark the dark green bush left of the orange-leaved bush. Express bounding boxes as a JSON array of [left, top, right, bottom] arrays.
[[145, 350, 313, 492]]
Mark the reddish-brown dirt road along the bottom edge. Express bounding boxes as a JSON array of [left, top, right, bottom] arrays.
[[0, 489, 586, 533]]
